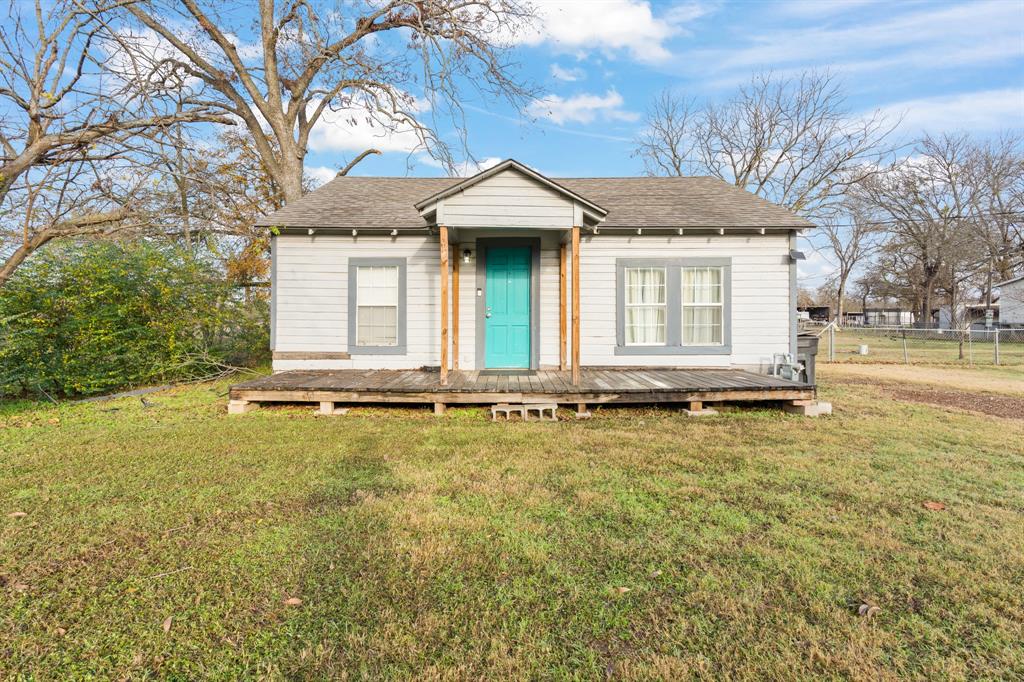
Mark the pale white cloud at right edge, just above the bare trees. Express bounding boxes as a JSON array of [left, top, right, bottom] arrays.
[[882, 88, 1024, 134]]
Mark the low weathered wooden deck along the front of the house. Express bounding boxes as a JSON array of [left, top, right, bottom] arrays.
[[229, 368, 815, 406]]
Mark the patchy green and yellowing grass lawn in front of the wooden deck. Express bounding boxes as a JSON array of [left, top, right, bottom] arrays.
[[0, 374, 1024, 680]]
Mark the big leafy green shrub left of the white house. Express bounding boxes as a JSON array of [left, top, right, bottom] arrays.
[[0, 242, 268, 397]]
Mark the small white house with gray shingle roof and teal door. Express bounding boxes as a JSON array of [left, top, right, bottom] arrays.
[[257, 160, 812, 383]]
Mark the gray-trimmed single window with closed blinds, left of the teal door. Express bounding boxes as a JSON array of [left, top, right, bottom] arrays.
[[348, 258, 406, 354]]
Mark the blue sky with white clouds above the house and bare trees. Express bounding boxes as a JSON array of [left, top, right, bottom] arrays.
[[299, 0, 1024, 182]]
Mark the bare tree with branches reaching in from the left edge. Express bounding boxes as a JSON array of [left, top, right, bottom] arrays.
[[0, 0, 229, 286]]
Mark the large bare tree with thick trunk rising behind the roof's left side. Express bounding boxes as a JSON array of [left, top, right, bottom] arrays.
[[118, 0, 532, 202]]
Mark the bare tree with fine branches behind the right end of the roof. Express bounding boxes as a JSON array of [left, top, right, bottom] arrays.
[[635, 72, 899, 218]]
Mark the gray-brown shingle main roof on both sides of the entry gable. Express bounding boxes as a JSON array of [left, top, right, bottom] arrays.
[[256, 176, 813, 229]]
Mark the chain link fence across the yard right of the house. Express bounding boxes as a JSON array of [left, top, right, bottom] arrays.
[[806, 324, 1024, 372]]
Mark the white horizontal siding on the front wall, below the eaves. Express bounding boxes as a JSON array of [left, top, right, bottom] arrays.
[[274, 229, 791, 370]]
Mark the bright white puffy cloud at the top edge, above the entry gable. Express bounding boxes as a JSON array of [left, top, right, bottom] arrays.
[[514, 0, 708, 62]]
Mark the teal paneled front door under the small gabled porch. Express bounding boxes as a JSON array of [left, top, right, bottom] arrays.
[[483, 247, 531, 369]]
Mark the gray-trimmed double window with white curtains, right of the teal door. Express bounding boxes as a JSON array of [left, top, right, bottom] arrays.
[[615, 258, 732, 355]]
